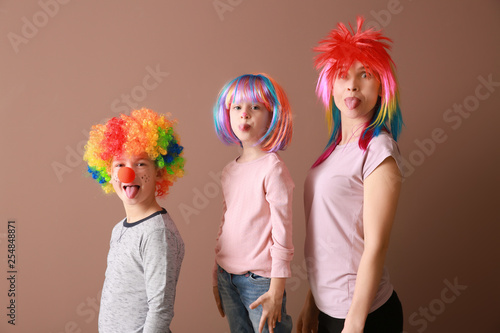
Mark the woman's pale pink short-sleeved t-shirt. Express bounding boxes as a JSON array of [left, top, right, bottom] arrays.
[[304, 132, 402, 318]]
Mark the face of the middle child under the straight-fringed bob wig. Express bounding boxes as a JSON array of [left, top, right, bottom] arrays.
[[229, 101, 271, 147]]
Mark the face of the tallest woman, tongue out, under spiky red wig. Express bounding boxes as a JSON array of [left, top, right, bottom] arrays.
[[333, 61, 381, 122]]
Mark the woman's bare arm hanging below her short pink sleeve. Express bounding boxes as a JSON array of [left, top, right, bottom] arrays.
[[342, 157, 401, 333]]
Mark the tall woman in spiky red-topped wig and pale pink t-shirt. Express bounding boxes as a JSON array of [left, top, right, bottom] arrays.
[[297, 18, 403, 333]]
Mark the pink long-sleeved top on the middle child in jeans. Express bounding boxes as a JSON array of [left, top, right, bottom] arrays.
[[214, 153, 294, 285]]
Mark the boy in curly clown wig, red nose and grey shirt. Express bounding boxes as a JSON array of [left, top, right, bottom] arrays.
[[83, 109, 184, 333]]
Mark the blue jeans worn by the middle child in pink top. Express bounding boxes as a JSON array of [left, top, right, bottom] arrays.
[[217, 266, 292, 333]]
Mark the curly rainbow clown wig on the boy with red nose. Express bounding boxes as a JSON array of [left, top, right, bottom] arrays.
[[83, 108, 184, 197]]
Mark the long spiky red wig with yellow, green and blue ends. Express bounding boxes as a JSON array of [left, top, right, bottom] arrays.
[[313, 17, 403, 167]]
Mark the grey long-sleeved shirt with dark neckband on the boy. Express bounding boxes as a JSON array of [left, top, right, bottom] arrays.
[[99, 209, 184, 333]]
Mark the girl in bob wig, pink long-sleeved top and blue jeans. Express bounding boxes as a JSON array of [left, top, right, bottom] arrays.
[[213, 74, 294, 333]]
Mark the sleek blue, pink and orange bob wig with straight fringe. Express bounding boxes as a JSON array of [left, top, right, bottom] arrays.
[[213, 73, 292, 152]]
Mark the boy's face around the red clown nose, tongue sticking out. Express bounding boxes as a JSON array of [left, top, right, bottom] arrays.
[[111, 153, 161, 205]]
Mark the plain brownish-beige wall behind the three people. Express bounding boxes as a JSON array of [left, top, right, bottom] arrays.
[[0, 0, 500, 333]]
